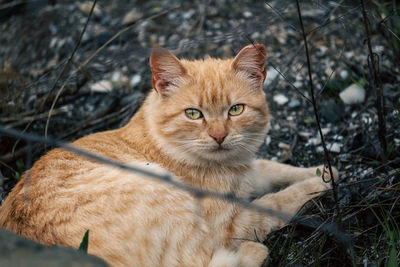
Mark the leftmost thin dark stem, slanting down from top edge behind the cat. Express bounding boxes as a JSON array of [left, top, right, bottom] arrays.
[[44, 0, 97, 136]]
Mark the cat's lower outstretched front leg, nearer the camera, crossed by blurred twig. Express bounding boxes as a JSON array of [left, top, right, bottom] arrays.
[[234, 175, 337, 244]]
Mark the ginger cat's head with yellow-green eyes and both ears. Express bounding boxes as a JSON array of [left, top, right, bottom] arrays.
[[146, 45, 269, 165]]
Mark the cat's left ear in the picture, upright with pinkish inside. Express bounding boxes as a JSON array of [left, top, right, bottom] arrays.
[[150, 48, 186, 96]]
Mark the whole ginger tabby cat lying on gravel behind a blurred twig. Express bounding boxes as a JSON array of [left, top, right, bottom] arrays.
[[0, 45, 337, 266]]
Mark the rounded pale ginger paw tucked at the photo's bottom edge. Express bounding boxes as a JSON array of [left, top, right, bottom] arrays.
[[238, 241, 268, 267]]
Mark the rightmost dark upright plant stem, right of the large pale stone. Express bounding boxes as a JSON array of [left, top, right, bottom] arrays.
[[360, 0, 387, 161]]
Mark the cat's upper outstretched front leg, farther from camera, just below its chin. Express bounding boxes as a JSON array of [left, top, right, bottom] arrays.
[[243, 159, 338, 194]]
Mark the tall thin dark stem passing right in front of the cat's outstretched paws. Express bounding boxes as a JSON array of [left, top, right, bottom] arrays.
[[296, 0, 340, 221]]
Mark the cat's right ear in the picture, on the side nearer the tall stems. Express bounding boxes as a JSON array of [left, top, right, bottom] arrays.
[[232, 44, 267, 87]]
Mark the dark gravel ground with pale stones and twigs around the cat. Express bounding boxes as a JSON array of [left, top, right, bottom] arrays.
[[0, 0, 400, 266]]
